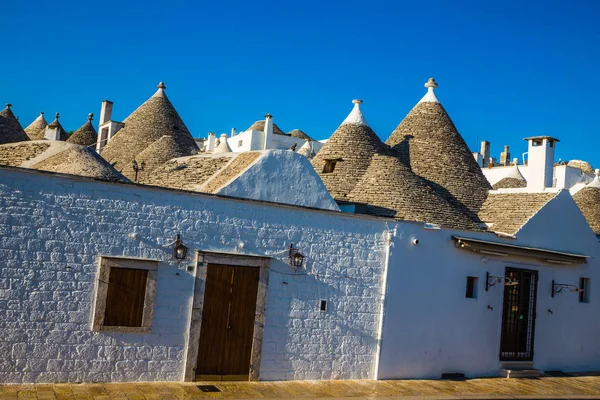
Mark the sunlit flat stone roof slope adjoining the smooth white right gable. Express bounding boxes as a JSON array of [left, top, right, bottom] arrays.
[[479, 192, 559, 235]]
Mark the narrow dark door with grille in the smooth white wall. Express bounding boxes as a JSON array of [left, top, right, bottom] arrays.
[[500, 268, 538, 361]]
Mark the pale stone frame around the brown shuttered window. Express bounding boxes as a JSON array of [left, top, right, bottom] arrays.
[[92, 256, 158, 333]]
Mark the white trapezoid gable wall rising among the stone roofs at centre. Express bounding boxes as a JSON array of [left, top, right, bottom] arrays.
[[217, 150, 340, 211]]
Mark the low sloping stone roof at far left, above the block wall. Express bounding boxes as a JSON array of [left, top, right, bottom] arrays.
[[0, 140, 129, 182]]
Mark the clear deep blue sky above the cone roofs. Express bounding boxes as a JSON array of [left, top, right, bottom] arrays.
[[0, 0, 600, 167]]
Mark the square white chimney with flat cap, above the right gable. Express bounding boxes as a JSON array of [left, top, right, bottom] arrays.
[[525, 136, 559, 191]]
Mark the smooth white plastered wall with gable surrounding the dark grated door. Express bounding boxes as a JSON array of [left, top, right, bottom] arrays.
[[378, 191, 600, 379]]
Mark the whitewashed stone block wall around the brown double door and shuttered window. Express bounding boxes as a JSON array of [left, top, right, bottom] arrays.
[[0, 168, 386, 383]]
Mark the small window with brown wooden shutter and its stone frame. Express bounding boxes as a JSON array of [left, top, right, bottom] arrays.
[[92, 257, 158, 333]]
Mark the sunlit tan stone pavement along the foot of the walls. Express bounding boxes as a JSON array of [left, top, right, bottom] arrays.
[[0, 376, 600, 400]]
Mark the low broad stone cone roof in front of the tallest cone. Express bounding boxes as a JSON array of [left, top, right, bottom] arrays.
[[348, 152, 478, 230]]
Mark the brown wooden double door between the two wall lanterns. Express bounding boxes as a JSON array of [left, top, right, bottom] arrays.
[[196, 264, 260, 380]]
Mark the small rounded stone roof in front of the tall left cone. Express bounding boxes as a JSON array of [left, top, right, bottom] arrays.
[[135, 135, 202, 183]]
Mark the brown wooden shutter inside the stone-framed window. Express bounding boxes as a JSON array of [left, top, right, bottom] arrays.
[[104, 267, 148, 327]]
